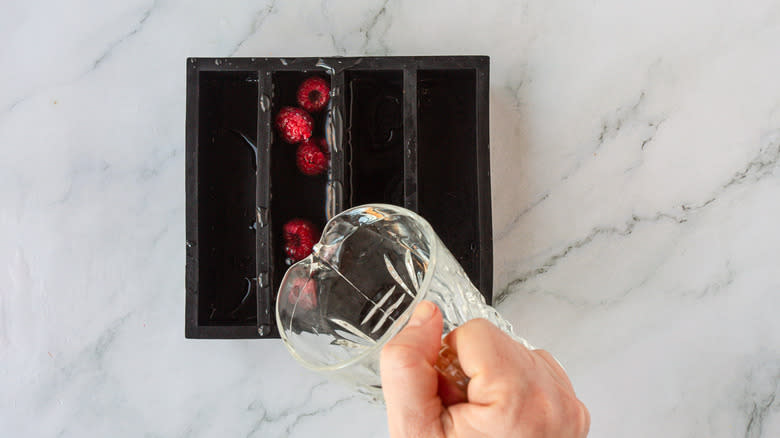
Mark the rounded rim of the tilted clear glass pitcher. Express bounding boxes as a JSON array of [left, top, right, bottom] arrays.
[[274, 203, 440, 372]]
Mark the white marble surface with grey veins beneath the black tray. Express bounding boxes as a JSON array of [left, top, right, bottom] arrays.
[[0, 0, 780, 438]]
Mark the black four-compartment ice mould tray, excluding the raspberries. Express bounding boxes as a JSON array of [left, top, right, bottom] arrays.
[[185, 56, 493, 339]]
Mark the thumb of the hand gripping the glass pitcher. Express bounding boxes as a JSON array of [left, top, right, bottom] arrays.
[[380, 301, 443, 437]]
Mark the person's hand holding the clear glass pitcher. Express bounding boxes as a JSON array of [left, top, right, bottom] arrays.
[[381, 301, 590, 438]]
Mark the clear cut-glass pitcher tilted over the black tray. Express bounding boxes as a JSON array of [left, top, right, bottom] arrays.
[[276, 204, 530, 400]]
